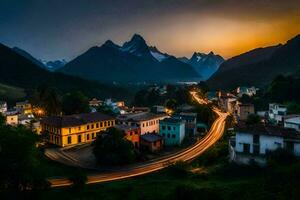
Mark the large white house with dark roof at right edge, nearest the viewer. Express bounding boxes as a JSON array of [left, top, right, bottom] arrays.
[[230, 123, 300, 165]]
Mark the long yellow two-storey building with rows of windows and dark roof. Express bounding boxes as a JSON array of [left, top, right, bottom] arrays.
[[41, 112, 115, 147]]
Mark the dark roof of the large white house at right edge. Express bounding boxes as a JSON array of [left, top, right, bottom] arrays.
[[236, 122, 300, 139]]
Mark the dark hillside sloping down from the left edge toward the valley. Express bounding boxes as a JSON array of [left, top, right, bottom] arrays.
[[0, 44, 131, 99]]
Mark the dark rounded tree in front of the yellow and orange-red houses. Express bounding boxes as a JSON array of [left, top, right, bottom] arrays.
[[93, 128, 136, 165]]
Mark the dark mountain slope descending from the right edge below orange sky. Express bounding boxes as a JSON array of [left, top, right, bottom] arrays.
[[207, 35, 300, 89]]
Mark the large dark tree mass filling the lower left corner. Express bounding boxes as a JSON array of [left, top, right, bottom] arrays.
[[0, 125, 49, 191]]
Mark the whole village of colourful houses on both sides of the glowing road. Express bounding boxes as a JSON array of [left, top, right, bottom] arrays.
[[0, 83, 300, 168]]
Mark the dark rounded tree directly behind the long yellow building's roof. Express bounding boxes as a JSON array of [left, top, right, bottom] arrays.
[[62, 91, 90, 115]]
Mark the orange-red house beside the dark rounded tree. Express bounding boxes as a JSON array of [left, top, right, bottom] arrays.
[[115, 124, 141, 148]]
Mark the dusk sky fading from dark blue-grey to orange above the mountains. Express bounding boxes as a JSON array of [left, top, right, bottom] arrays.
[[0, 0, 300, 60]]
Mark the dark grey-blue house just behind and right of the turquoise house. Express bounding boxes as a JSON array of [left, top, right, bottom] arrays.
[[173, 112, 197, 137]]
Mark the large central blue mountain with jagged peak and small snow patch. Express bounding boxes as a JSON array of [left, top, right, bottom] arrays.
[[58, 34, 223, 82]]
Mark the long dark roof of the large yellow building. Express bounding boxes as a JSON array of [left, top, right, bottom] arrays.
[[41, 112, 114, 127]]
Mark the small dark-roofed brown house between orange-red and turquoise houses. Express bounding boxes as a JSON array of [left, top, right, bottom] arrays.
[[141, 133, 164, 152]]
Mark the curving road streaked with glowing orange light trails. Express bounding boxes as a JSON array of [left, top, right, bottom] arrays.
[[49, 92, 227, 187]]
